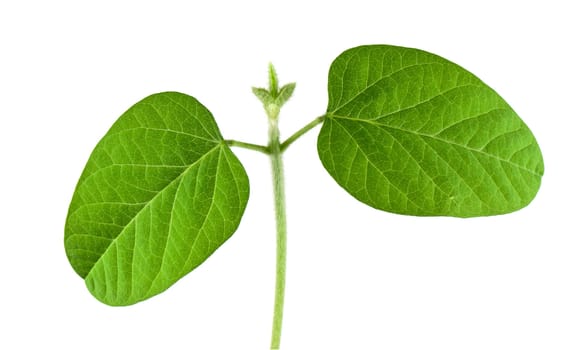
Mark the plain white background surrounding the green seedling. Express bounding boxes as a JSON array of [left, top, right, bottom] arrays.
[[0, 0, 581, 350]]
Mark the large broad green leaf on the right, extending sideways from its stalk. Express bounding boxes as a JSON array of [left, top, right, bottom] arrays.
[[318, 45, 543, 217]]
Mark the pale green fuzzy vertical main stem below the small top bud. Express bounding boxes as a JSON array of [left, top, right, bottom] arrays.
[[268, 118, 286, 349]]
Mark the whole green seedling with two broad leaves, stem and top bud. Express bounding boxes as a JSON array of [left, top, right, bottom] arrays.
[[65, 45, 543, 349]]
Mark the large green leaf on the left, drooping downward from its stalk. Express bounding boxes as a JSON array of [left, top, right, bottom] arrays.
[[65, 92, 249, 305]]
